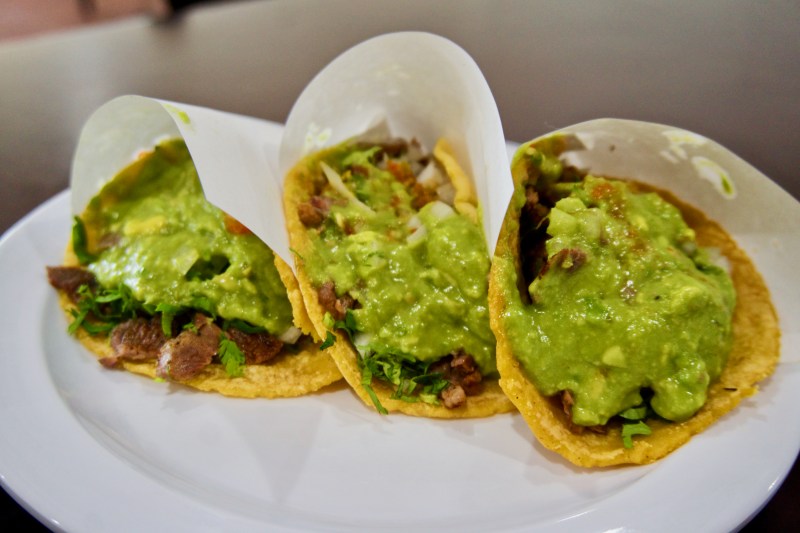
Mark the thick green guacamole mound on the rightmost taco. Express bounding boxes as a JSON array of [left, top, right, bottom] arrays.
[[503, 148, 735, 426]]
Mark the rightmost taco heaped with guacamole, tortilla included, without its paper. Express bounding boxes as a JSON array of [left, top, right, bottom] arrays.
[[489, 135, 780, 466]]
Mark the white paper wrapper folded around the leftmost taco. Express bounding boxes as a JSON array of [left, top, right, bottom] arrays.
[[71, 96, 291, 263]]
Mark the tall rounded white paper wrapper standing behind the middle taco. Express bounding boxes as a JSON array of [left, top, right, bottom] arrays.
[[279, 32, 512, 253]]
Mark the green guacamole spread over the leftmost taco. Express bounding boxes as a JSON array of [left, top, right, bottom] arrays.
[[82, 140, 292, 335]]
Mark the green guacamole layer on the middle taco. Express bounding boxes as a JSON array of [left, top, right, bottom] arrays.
[[304, 141, 496, 376]]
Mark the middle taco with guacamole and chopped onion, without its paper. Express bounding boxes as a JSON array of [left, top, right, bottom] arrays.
[[284, 133, 513, 418]]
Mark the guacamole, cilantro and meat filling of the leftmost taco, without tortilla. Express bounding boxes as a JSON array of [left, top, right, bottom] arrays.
[[48, 139, 300, 378]]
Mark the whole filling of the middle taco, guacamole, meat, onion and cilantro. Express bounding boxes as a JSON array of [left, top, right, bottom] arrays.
[[299, 137, 497, 410]]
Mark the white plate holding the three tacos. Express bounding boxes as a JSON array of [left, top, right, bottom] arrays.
[[0, 185, 800, 532]]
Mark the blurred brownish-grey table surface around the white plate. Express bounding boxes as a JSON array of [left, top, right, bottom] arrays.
[[0, 0, 800, 531]]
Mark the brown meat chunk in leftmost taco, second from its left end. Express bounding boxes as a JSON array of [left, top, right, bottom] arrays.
[[100, 317, 167, 368]]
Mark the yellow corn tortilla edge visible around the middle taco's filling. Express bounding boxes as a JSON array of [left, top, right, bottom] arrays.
[[283, 137, 514, 419]]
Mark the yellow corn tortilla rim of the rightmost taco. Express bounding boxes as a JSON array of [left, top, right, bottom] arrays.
[[489, 139, 780, 467]]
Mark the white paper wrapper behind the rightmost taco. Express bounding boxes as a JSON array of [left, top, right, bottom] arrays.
[[524, 119, 800, 365]]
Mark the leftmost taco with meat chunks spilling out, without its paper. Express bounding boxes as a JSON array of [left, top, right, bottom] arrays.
[[47, 140, 341, 398]]
